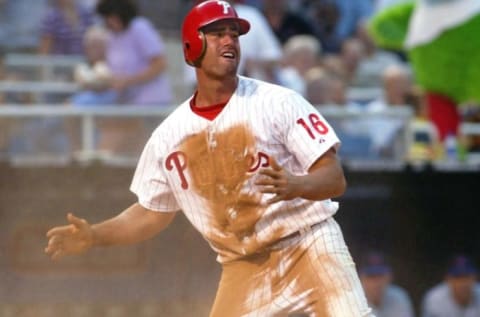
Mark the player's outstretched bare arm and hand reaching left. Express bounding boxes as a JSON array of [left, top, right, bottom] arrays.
[[45, 203, 175, 260]]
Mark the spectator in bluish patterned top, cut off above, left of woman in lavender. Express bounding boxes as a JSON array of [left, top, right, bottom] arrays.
[[38, 0, 95, 55]]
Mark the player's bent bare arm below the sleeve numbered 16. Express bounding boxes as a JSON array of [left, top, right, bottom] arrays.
[[256, 148, 347, 203]]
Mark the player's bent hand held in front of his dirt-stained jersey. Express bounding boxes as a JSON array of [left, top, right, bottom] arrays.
[[255, 158, 301, 204]]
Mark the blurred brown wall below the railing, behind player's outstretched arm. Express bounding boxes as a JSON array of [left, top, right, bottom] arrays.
[[0, 166, 219, 317]]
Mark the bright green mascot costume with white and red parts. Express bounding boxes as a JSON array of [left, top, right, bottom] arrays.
[[369, 0, 480, 140]]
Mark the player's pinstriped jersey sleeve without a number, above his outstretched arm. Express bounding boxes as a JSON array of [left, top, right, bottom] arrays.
[[130, 132, 180, 212]]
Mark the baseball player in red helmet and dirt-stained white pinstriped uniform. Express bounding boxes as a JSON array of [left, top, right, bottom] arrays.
[[45, 0, 372, 317]]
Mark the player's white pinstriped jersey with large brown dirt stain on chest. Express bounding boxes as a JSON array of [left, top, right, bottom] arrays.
[[130, 76, 339, 263]]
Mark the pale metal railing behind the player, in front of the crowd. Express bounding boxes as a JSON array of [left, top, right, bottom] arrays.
[[0, 104, 480, 170]]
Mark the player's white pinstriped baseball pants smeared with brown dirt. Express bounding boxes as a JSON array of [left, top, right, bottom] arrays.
[[210, 218, 373, 317]]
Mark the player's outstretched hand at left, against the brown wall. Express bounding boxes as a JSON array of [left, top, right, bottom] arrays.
[[45, 213, 94, 260]]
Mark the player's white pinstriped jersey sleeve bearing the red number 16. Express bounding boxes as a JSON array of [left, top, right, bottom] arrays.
[[277, 93, 340, 171]]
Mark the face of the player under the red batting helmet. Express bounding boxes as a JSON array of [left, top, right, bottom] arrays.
[[201, 21, 240, 77]]
